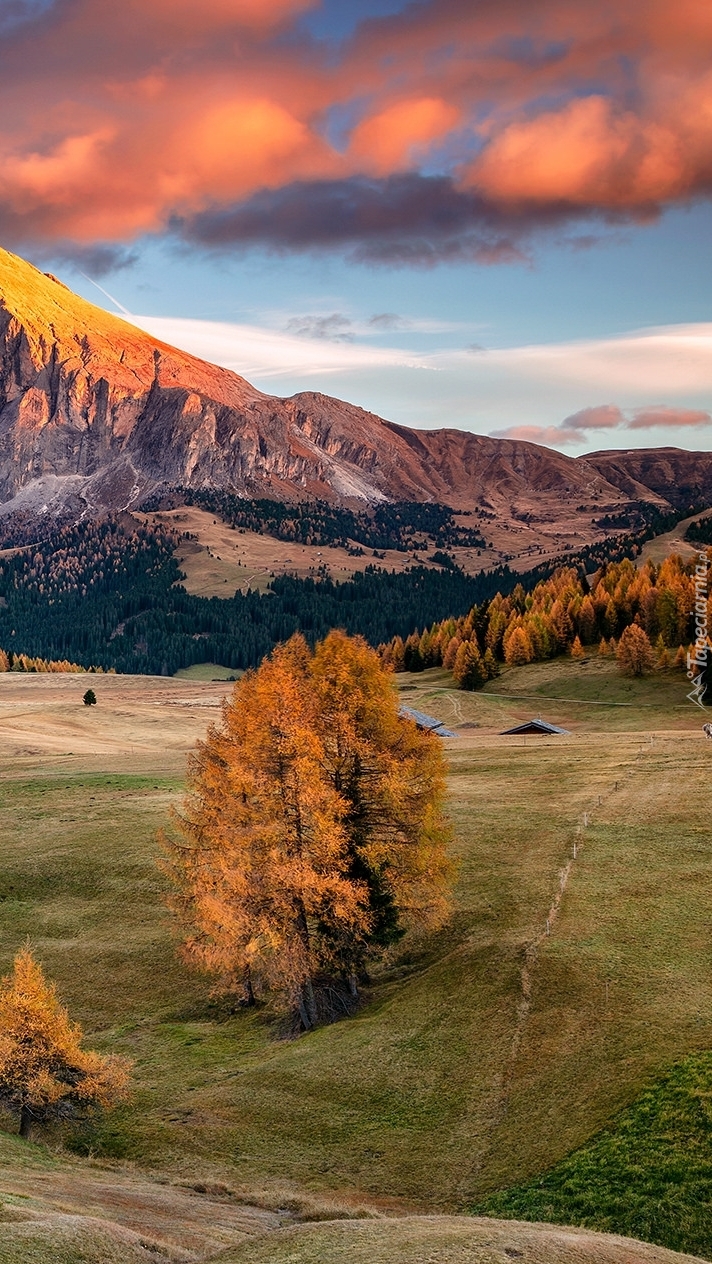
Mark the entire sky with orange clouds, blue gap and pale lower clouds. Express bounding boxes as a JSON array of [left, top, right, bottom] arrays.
[[0, 0, 712, 455]]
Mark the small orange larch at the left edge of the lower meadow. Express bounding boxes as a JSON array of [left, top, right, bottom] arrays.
[[0, 947, 132, 1139]]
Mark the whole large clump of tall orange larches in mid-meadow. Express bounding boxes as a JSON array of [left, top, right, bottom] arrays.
[[166, 633, 448, 1029]]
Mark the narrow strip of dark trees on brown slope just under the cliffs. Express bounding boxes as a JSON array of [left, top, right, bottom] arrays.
[[143, 488, 487, 552]]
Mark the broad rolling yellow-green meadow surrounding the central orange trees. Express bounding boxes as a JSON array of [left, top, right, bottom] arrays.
[[0, 660, 712, 1264]]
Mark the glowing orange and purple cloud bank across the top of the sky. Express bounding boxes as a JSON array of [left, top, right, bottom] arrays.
[[0, 0, 712, 264]]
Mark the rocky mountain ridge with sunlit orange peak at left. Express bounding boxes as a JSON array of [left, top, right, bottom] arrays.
[[0, 252, 712, 542]]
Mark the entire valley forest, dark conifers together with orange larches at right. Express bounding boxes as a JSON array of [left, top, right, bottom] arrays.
[[0, 502, 708, 688]]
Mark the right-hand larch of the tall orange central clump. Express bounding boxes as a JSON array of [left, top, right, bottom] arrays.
[[310, 632, 449, 992]]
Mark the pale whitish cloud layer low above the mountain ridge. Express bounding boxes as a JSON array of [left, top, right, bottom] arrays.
[[129, 312, 712, 453]]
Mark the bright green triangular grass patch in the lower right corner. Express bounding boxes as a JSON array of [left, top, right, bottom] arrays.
[[477, 1053, 712, 1258]]
